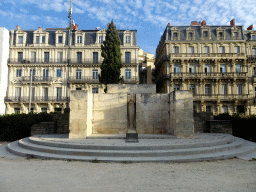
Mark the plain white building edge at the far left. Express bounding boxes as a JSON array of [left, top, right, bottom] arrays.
[[0, 27, 9, 115]]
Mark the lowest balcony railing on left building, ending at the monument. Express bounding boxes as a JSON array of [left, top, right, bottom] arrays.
[[4, 96, 69, 103]]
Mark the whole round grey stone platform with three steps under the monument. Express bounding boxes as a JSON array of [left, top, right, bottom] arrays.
[[7, 133, 256, 162]]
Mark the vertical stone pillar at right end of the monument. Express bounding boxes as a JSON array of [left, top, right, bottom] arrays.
[[170, 90, 194, 138]]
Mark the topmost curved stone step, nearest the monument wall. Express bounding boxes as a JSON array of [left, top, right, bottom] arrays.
[[28, 134, 235, 150]]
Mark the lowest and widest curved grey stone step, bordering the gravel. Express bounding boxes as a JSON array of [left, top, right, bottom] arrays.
[[8, 139, 256, 162]]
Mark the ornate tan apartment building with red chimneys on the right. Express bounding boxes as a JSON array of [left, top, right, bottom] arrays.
[[155, 19, 256, 115]]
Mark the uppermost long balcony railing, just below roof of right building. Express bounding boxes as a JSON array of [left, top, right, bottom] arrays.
[[169, 53, 245, 57]]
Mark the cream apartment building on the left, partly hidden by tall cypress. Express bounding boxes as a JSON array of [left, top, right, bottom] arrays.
[[5, 24, 139, 114]]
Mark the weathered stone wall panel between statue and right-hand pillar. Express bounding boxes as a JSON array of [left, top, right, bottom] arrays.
[[136, 94, 170, 134]]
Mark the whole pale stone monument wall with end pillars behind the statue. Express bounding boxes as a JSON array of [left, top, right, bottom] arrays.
[[69, 85, 194, 139]]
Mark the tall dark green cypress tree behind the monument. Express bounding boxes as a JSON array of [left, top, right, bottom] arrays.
[[99, 19, 123, 92]]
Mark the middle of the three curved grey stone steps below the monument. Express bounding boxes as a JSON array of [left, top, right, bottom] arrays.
[[7, 138, 244, 157]]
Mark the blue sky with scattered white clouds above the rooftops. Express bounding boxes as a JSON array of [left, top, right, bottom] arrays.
[[0, 0, 256, 55]]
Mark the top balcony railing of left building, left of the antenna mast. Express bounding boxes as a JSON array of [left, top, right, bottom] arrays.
[[8, 58, 68, 64]]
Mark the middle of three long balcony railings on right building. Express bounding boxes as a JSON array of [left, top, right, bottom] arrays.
[[166, 72, 247, 79]]
